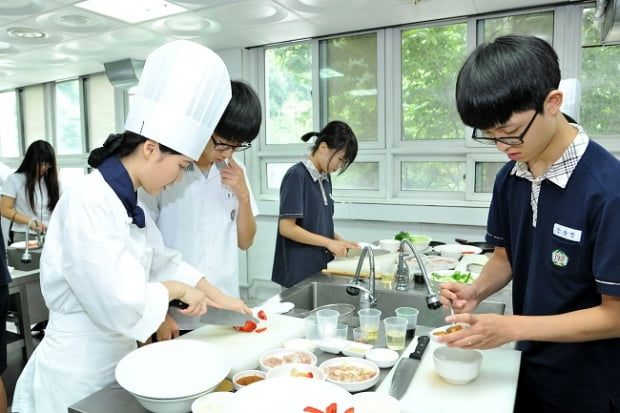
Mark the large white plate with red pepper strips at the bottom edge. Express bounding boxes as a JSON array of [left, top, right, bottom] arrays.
[[224, 377, 353, 413]]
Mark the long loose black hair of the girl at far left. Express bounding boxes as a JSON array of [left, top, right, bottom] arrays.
[[15, 140, 60, 211]]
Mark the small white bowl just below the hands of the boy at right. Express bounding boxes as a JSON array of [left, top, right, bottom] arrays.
[[433, 346, 482, 384]]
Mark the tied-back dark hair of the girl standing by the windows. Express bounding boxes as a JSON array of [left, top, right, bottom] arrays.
[[301, 120, 357, 174]]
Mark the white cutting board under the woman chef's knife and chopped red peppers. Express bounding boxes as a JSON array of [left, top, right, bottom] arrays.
[[181, 313, 304, 378]]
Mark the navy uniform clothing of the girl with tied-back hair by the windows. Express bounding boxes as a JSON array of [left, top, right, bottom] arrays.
[[271, 157, 334, 287]]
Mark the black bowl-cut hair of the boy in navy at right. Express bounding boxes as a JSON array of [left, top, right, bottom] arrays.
[[456, 35, 561, 129]]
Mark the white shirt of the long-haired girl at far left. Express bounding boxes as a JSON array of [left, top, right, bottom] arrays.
[[2, 172, 52, 234]]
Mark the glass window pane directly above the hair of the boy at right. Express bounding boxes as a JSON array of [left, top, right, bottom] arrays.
[[483, 11, 553, 44]]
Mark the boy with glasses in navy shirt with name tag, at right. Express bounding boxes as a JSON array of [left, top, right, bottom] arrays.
[[440, 36, 620, 413]]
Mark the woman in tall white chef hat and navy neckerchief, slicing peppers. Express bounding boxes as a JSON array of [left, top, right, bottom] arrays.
[[12, 41, 250, 413]]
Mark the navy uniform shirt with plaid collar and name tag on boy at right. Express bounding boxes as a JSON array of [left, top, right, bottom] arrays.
[[486, 125, 620, 413]]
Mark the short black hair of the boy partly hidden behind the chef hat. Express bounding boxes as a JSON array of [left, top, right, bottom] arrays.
[[213, 80, 262, 143]]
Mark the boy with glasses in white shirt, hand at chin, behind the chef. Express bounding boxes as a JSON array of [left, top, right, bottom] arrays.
[[138, 80, 262, 332]]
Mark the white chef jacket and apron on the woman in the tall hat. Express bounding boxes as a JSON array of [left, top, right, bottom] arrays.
[[12, 170, 203, 413]]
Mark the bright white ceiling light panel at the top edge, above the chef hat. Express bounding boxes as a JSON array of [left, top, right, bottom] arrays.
[[74, 0, 187, 23]]
